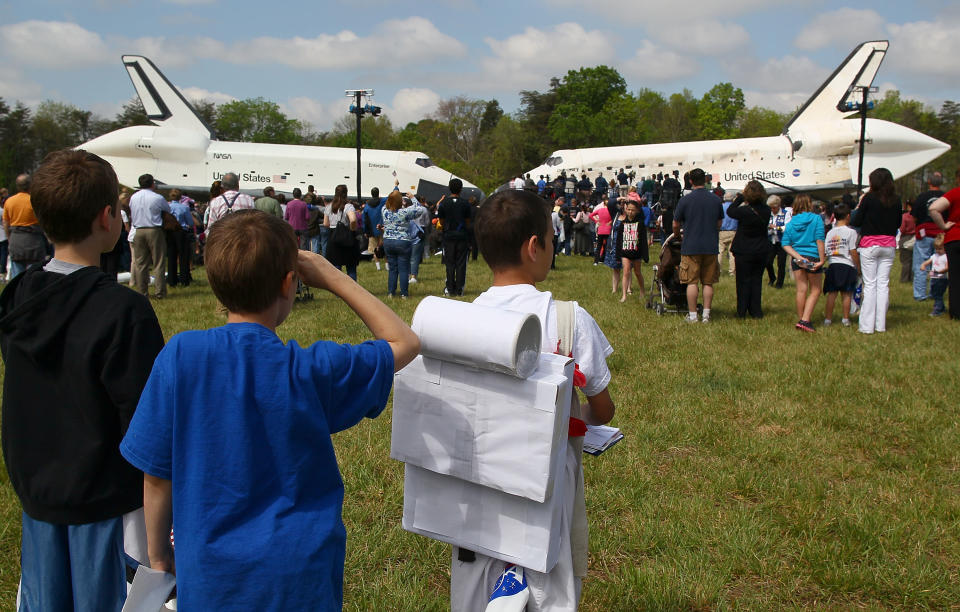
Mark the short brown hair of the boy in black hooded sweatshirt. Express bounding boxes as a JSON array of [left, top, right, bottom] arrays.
[[30, 149, 120, 244]]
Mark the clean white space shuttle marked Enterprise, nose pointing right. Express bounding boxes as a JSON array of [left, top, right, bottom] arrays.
[[78, 55, 483, 202]]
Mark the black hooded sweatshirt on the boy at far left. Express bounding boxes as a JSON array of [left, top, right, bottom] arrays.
[[0, 266, 163, 524]]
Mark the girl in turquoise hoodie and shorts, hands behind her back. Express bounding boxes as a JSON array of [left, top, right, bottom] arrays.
[[782, 193, 826, 332]]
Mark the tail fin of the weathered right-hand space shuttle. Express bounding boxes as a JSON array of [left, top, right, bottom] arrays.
[[783, 40, 890, 134]]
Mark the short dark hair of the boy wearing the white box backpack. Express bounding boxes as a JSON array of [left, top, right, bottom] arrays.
[[474, 189, 550, 270]]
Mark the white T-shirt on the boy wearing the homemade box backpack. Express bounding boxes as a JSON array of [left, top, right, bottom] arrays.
[[474, 285, 613, 397]]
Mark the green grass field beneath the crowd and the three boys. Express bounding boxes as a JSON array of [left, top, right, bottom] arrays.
[[0, 251, 960, 611]]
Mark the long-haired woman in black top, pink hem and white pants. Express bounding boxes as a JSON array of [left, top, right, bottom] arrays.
[[850, 168, 902, 334]]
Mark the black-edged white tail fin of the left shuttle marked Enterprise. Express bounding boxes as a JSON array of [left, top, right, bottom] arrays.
[[123, 55, 214, 138]]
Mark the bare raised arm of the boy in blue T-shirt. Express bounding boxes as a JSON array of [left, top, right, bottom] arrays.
[[297, 251, 420, 372]]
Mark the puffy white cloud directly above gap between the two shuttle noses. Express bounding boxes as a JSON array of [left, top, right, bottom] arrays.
[[480, 23, 616, 90]]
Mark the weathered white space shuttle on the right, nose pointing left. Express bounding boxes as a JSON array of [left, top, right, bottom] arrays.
[[529, 40, 950, 197]]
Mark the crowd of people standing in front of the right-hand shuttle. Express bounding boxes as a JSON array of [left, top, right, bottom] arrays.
[[510, 168, 960, 334]]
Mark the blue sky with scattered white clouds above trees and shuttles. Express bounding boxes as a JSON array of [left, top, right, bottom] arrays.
[[0, 0, 960, 130]]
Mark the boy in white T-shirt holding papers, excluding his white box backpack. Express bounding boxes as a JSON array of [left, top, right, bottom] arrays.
[[450, 190, 614, 612]]
